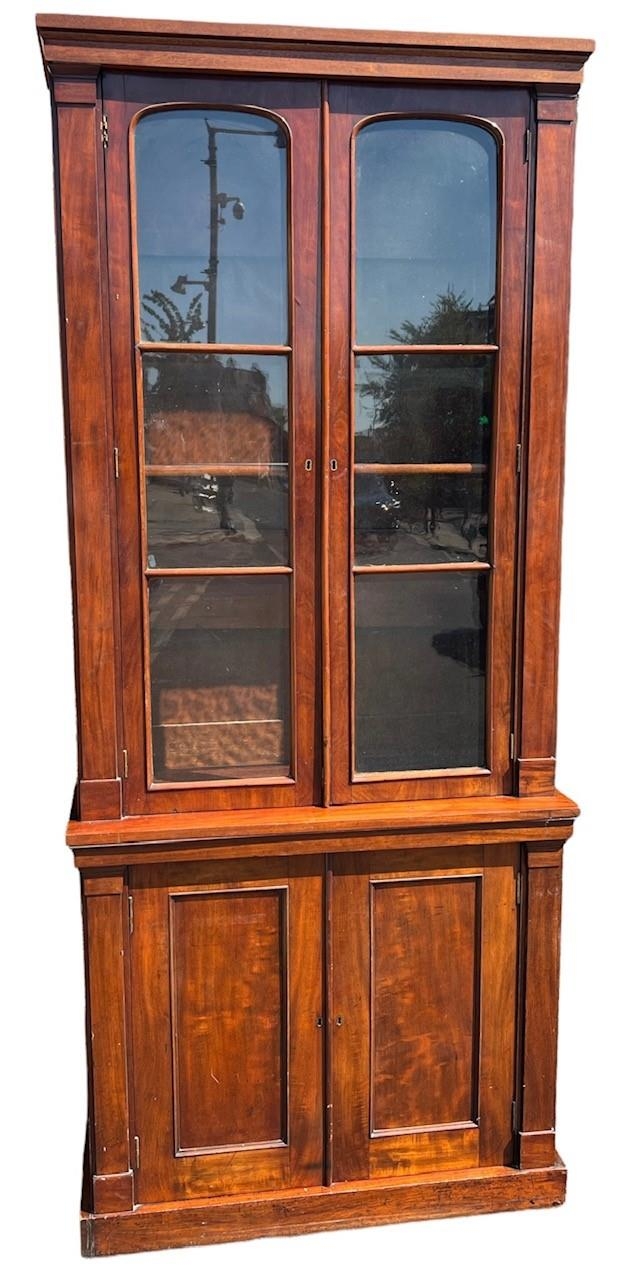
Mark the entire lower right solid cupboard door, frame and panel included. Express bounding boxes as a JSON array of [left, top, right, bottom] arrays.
[[330, 846, 518, 1181]]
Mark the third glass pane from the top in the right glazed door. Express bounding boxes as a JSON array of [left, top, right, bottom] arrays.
[[354, 472, 488, 564]]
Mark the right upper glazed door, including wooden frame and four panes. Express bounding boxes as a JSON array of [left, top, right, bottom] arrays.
[[325, 84, 528, 804]]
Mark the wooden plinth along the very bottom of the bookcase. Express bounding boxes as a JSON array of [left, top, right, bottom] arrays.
[[81, 1162, 566, 1257]]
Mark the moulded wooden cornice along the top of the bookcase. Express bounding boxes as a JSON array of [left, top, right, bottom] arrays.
[[36, 14, 594, 93]]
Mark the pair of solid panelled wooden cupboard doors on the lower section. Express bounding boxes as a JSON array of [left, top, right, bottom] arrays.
[[129, 845, 518, 1204]]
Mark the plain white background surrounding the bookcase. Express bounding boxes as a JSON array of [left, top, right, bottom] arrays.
[[0, 0, 627, 1280]]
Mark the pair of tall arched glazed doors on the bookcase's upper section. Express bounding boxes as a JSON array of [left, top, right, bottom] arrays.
[[92, 73, 530, 814]]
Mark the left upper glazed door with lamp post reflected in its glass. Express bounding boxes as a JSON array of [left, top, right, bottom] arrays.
[[104, 76, 320, 813]]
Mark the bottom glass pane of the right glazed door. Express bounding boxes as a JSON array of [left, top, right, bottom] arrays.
[[354, 572, 488, 773]]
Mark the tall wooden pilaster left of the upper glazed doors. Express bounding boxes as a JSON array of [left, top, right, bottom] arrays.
[[54, 79, 122, 819]]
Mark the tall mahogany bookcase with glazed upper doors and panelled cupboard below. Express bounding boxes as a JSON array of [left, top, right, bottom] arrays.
[[37, 15, 592, 1254]]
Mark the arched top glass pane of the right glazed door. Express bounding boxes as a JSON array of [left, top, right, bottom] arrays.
[[356, 119, 496, 346]]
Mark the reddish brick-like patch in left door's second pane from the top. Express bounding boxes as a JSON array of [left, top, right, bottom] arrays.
[[146, 410, 282, 471]]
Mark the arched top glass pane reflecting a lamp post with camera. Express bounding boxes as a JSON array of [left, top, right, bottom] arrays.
[[136, 109, 288, 343]]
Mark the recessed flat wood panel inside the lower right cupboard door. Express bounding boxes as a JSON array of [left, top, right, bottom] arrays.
[[370, 876, 481, 1137]]
